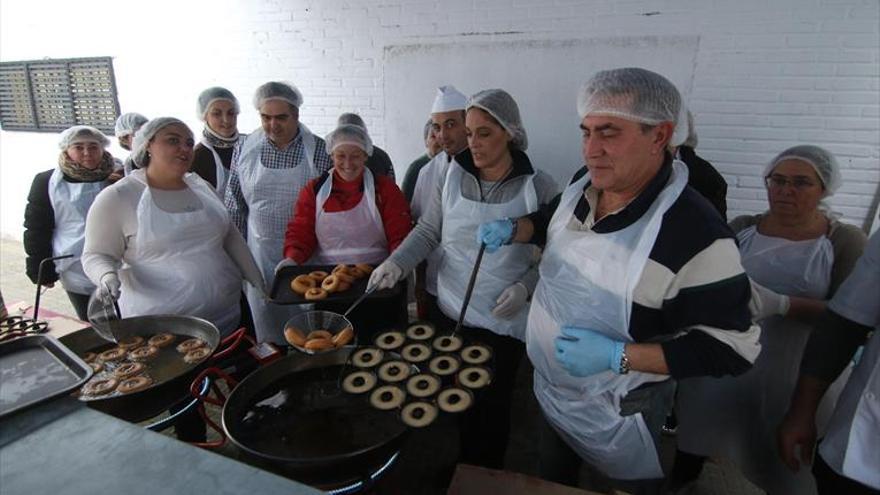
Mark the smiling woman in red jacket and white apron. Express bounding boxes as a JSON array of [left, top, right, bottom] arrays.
[[278, 124, 412, 343]]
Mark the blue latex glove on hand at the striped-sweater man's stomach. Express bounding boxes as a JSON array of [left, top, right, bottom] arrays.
[[556, 327, 626, 376]]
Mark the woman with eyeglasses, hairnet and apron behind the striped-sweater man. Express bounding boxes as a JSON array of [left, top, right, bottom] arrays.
[[672, 145, 866, 494]]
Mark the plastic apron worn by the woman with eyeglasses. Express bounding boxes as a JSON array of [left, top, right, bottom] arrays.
[[677, 226, 851, 494]]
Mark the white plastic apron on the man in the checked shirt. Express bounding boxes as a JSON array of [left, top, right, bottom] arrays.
[[235, 128, 318, 344]]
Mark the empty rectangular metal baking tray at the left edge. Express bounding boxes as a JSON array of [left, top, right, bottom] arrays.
[[0, 335, 93, 418]]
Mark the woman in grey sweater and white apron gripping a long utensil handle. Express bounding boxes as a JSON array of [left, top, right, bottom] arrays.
[[370, 89, 556, 468]]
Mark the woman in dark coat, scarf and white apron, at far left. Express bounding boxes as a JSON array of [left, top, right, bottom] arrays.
[[24, 126, 115, 320]]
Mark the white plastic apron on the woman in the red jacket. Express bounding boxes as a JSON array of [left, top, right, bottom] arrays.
[[310, 168, 388, 265]]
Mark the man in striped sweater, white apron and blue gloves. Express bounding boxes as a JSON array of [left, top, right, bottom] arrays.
[[477, 68, 760, 493]]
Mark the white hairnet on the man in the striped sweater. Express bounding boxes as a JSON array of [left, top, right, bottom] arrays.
[[577, 67, 681, 125]]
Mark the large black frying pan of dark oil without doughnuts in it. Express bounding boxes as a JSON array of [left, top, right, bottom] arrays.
[[215, 346, 408, 486]]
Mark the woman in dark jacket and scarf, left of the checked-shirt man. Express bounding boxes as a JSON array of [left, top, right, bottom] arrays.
[[190, 87, 246, 198]]
